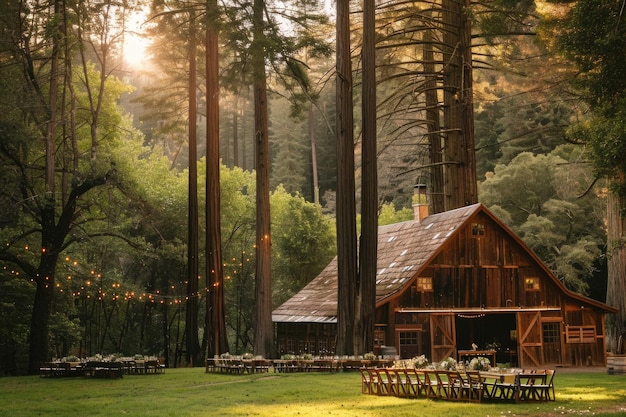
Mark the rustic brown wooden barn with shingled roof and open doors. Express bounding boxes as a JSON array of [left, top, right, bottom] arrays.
[[272, 204, 616, 367]]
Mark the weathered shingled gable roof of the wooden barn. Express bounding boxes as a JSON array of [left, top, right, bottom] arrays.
[[272, 203, 612, 323]]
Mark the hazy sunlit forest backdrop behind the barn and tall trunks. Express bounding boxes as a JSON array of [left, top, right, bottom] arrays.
[[0, 1, 617, 374]]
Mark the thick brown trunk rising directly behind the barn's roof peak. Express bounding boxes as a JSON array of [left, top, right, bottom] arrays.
[[442, 0, 478, 210]]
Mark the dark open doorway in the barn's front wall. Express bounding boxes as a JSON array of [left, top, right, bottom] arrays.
[[455, 312, 517, 366]]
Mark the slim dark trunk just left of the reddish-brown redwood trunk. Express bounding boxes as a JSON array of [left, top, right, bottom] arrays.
[[185, 11, 200, 366]]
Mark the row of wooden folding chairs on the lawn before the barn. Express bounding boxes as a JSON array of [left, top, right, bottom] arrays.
[[360, 368, 555, 402]]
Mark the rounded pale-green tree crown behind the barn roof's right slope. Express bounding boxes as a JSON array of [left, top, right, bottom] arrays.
[[479, 149, 605, 294]]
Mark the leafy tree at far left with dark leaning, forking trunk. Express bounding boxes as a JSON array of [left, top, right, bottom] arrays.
[[0, 1, 147, 372]]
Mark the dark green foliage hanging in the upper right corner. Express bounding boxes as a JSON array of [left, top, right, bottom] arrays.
[[557, 0, 626, 198]]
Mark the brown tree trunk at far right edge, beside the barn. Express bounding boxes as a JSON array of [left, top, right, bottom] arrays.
[[606, 184, 626, 353]]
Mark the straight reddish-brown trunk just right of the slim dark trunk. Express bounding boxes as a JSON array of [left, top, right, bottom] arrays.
[[206, 0, 228, 356]]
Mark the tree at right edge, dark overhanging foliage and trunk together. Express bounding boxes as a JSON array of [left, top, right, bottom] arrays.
[[551, 0, 626, 350]]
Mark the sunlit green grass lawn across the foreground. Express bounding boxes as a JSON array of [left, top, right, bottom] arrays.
[[0, 368, 626, 417]]
